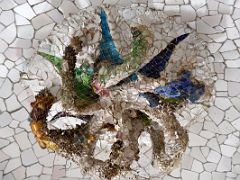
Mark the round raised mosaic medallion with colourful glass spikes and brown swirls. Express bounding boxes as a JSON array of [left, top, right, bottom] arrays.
[[24, 6, 214, 179]]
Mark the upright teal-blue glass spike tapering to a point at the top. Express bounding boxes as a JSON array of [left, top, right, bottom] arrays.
[[99, 9, 123, 64]]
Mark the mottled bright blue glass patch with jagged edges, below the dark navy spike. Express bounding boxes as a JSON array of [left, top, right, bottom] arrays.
[[154, 71, 205, 103]]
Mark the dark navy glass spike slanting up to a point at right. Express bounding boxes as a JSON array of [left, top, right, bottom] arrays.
[[138, 33, 189, 79]]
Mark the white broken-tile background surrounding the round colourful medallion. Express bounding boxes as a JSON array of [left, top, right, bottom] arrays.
[[0, 0, 240, 180]]
